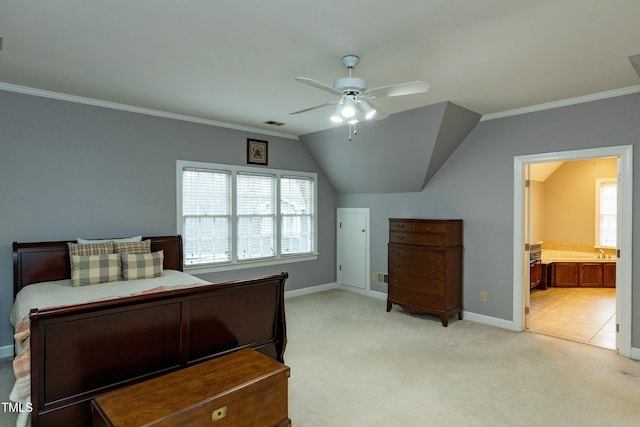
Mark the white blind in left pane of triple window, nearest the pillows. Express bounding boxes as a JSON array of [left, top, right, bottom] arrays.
[[182, 168, 231, 265]]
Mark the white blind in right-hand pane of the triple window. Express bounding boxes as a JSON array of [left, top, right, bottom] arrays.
[[280, 177, 314, 254]]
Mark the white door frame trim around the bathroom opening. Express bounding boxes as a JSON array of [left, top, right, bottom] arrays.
[[513, 146, 632, 357]]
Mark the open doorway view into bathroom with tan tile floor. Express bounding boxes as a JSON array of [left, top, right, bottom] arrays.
[[526, 157, 618, 350]]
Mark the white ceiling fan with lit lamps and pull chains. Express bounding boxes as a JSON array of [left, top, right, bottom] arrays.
[[290, 55, 429, 139]]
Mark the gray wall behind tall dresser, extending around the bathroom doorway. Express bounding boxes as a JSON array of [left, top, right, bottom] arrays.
[[338, 94, 640, 348]]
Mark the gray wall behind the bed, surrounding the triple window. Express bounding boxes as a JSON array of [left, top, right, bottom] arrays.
[[0, 91, 336, 347]]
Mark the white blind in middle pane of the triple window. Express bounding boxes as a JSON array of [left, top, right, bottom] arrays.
[[236, 172, 276, 260]]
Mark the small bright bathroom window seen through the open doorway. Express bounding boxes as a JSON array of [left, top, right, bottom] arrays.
[[596, 178, 618, 248]]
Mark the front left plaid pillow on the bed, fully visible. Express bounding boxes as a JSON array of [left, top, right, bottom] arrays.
[[71, 254, 121, 286]]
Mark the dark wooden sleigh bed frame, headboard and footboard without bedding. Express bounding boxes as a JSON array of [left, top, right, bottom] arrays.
[[13, 236, 288, 426]]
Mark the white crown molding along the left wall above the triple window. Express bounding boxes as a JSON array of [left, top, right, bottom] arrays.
[[0, 82, 298, 141]]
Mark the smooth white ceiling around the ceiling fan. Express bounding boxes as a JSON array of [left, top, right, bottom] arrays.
[[0, 0, 640, 136]]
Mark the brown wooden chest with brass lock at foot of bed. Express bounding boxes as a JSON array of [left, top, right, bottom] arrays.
[[92, 349, 291, 427]]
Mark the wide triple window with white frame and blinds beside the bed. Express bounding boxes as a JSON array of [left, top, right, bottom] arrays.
[[177, 160, 317, 269]]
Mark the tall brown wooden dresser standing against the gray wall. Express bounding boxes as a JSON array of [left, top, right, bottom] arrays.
[[387, 218, 462, 326]]
